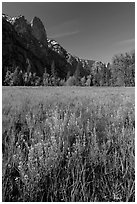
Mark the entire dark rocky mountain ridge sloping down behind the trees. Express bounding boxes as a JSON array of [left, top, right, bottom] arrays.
[[2, 14, 97, 78]]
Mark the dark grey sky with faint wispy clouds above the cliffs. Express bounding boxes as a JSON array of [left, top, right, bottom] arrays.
[[2, 2, 135, 63]]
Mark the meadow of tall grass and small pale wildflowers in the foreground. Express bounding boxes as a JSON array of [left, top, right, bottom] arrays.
[[2, 87, 135, 202]]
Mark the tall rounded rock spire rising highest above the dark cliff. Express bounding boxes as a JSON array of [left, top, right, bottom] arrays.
[[31, 17, 47, 47]]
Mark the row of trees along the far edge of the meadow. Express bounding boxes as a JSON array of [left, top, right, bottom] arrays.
[[3, 51, 135, 86]]
